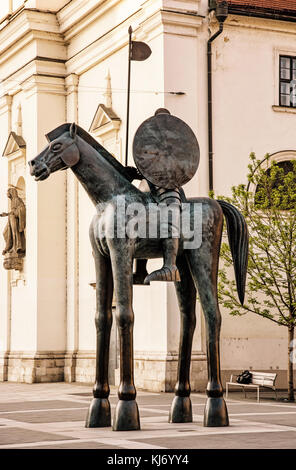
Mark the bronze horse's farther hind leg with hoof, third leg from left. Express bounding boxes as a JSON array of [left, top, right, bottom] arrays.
[[169, 256, 196, 423]]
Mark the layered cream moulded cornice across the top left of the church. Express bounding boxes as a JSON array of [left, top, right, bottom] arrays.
[[0, 0, 202, 94]]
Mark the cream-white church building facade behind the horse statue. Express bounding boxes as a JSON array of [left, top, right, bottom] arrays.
[[0, 0, 296, 391]]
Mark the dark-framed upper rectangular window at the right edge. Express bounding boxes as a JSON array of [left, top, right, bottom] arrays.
[[280, 56, 296, 108]]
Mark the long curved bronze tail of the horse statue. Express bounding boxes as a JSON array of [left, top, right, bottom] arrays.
[[217, 200, 249, 305]]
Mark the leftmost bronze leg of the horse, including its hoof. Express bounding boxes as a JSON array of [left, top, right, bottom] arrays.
[[85, 249, 113, 428]]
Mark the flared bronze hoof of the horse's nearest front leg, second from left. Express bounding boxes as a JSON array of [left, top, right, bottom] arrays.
[[113, 400, 140, 431]]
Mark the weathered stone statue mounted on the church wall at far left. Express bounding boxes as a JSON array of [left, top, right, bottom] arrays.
[[0, 185, 26, 271]]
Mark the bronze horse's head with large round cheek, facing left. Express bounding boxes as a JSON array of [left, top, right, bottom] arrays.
[[28, 123, 80, 181]]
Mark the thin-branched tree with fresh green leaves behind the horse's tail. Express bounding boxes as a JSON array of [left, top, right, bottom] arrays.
[[218, 154, 296, 401]]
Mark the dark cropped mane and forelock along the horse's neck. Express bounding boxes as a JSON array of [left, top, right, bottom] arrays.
[[45, 122, 128, 179]]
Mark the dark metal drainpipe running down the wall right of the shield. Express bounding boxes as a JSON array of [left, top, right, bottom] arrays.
[[208, 0, 228, 191]]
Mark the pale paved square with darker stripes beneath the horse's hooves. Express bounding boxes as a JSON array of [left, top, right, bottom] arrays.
[[0, 382, 296, 450]]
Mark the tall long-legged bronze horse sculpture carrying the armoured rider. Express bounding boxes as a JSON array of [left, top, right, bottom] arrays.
[[29, 123, 248, 431]]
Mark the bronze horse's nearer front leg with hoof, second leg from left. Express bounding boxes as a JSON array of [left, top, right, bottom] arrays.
[[110, 245, 140, 431]]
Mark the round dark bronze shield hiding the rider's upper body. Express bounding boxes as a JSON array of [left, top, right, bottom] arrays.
[[133, 113, 199, 189]]
